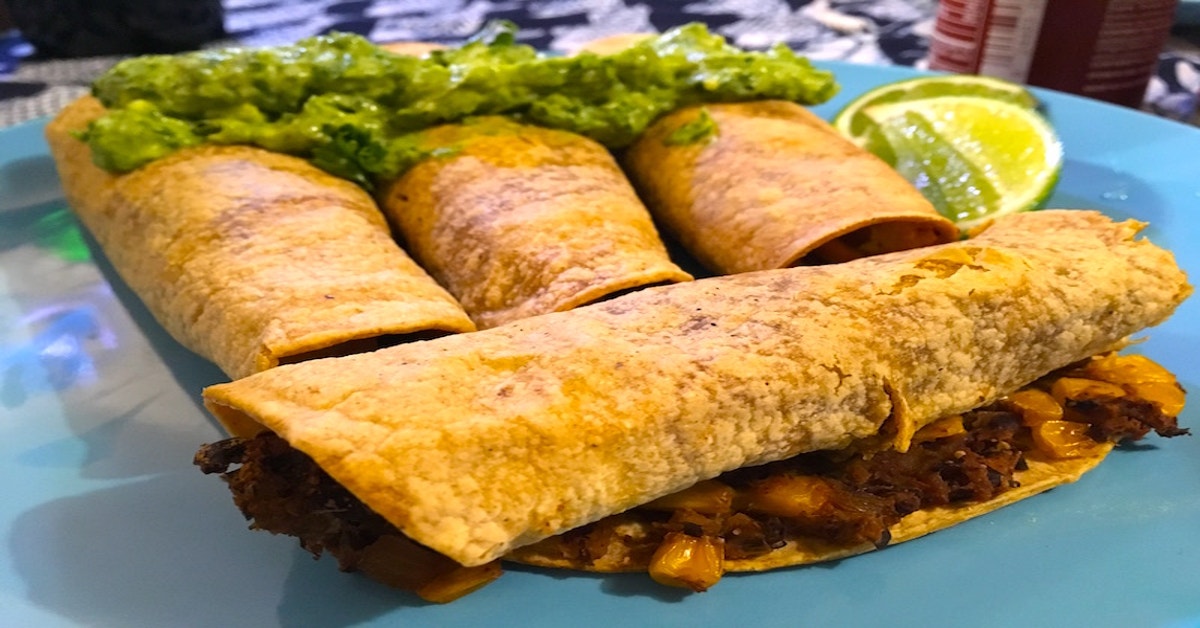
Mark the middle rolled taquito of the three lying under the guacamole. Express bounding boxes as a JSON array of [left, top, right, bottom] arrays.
[[379, 118, 691, 328]]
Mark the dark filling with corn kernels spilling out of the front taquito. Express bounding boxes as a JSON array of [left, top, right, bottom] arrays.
[[196, 354, 1188, 602]]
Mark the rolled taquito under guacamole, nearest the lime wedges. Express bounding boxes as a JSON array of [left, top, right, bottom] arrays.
[[623, 101, 959, 274]]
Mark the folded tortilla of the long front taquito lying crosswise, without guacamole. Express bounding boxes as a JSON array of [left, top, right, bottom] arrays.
[[204, 210, 1190, 566]]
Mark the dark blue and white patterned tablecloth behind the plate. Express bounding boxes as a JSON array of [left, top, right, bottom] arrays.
[[0, 0, 1200, 126]]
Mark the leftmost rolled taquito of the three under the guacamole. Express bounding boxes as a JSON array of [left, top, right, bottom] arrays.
[[46, 97, 474, 378]]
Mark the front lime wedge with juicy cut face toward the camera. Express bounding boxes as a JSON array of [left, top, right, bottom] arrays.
[[863, 96, 1062, 231]]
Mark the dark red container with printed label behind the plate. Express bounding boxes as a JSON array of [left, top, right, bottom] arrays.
[[929, 0, 1178, 107]]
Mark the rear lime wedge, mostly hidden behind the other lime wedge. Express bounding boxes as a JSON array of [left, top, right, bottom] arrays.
[[833, 74, 1038, 146]]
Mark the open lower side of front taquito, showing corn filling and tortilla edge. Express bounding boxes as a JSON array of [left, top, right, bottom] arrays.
[[505, 353, 1189, 591]]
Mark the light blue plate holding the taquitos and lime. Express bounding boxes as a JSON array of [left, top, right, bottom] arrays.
[[0, 64, 1200, 627]]
